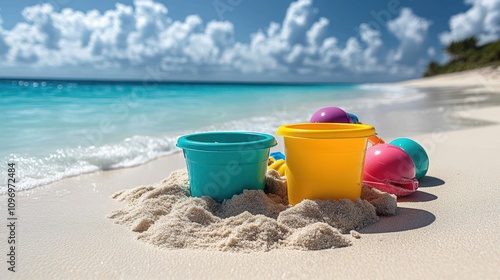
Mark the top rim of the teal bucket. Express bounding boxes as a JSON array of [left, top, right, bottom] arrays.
[[176, 131, 278, 152]]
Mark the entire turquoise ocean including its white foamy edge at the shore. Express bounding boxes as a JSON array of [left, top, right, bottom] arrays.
[[0, 80, 492, 193]]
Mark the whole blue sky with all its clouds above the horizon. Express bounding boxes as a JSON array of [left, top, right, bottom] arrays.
[[0, 0, 500, 82]]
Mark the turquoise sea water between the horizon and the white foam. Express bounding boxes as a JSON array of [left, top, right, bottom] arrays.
[[0, 81, 364, 154]]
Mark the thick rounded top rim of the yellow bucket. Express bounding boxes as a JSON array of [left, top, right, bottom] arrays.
[[276, 123, 375, 139]]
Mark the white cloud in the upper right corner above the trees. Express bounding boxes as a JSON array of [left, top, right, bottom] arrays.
[[439, 0, 500, 45]]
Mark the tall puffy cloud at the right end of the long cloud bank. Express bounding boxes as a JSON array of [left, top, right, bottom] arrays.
[[387, 8, 432, 65]]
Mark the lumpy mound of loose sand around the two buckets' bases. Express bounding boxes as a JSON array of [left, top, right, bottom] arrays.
[[108, 170, 397, 252]]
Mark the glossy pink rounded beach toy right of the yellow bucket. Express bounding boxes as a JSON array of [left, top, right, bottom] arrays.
[[363, 144, 418, 196]]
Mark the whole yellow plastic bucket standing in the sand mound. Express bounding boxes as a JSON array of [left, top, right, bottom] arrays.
[[277, 123, 375, 205]]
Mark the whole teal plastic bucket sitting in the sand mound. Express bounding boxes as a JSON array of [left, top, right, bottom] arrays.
[[177, 132, 276, 201]]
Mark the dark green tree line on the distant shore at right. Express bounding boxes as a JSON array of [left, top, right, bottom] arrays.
[[424, 36, 500, 77]]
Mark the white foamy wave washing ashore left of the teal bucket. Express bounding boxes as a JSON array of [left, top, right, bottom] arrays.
[[0, 136, 178, 194]]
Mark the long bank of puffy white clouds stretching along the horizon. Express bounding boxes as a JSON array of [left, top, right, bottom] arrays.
[[0, 0, 430, 81]]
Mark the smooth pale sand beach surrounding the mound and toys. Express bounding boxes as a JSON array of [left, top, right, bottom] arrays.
[[0, 69, 500, 279]]
